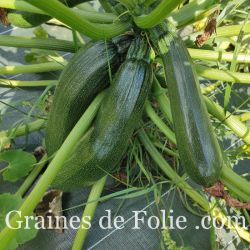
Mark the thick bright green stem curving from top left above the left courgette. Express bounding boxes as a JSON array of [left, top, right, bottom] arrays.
[[25, 0, 130, 40]]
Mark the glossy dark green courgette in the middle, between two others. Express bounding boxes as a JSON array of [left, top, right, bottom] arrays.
[[53, 38, 152, 191]]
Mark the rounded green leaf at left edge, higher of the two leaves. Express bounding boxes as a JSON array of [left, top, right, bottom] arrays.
[[0, 150, 36, 182]]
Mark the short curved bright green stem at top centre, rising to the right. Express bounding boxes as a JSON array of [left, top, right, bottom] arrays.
[[134, 0, 183, 29]]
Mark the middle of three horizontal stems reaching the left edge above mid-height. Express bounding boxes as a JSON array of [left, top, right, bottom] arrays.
[[0, 62, 67, 74]]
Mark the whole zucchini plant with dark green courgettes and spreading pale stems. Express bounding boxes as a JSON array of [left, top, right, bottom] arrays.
[[0, 0, 250, 249]]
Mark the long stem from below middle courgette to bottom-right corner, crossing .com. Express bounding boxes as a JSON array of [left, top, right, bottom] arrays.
[[139, 130, 250, 242]]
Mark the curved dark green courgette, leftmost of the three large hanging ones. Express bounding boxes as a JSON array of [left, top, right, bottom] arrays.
[[45, 35, 132, 156]]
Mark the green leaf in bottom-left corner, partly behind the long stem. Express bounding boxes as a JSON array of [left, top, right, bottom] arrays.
[[0, 193, 38, 250]]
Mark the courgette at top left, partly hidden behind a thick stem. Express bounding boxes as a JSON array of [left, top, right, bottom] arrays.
[[7, 0, 89, 28]]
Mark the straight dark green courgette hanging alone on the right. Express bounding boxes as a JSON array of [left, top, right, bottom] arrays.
[[149, 25, 224, 187]]
